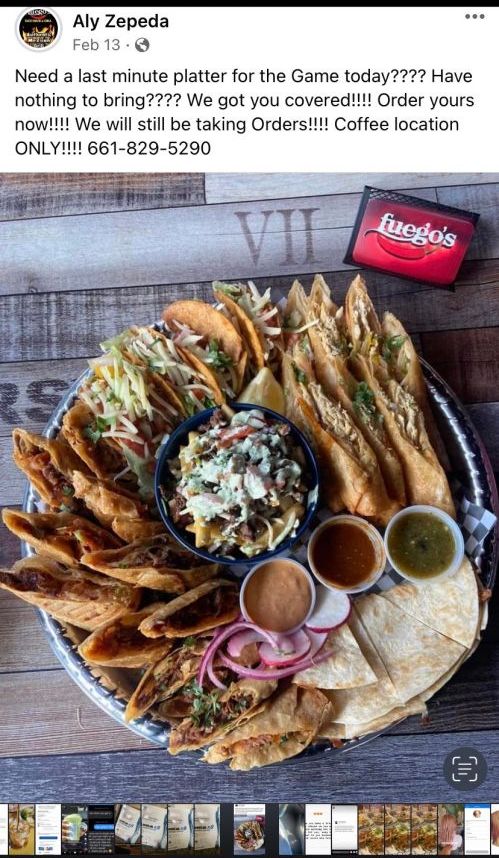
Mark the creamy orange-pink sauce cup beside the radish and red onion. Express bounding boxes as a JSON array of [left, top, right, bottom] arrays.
[[244, 558, 312, 632]]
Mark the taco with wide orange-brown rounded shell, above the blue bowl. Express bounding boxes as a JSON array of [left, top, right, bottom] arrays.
[[163, 301, 248, 399]]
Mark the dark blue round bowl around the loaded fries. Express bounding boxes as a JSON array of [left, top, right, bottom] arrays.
[[154, 402, 319, 566]]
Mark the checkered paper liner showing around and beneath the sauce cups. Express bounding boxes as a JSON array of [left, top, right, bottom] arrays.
[[231, 482, 497, 593]]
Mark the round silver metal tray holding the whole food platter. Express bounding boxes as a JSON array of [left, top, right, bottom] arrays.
[[23, 361, 499, 756]]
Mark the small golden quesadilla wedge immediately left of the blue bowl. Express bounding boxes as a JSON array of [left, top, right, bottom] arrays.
[[73, 471, 149, 529]]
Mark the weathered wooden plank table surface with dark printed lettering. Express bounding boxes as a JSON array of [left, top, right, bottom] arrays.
[[0, 173, 499, 802]]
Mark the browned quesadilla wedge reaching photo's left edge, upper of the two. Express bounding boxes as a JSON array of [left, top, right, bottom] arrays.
[[2, 509, 121, 564]]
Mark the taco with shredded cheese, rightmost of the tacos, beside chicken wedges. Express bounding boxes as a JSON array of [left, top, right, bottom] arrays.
[[213, 281, 284, 375]]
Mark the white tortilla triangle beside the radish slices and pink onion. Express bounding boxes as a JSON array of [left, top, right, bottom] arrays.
[[293, 623, 376, 689]]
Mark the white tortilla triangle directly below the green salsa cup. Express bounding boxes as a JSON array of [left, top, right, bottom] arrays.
[[382, 557, 479, 649]]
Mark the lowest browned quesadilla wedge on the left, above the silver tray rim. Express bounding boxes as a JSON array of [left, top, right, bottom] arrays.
[[78, 602, 173, 668]]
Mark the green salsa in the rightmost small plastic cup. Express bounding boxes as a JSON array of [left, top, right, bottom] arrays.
[[388, 512, 456, 578]]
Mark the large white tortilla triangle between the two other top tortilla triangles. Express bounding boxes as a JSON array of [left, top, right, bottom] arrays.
[[355, 594, 466, 703]]
